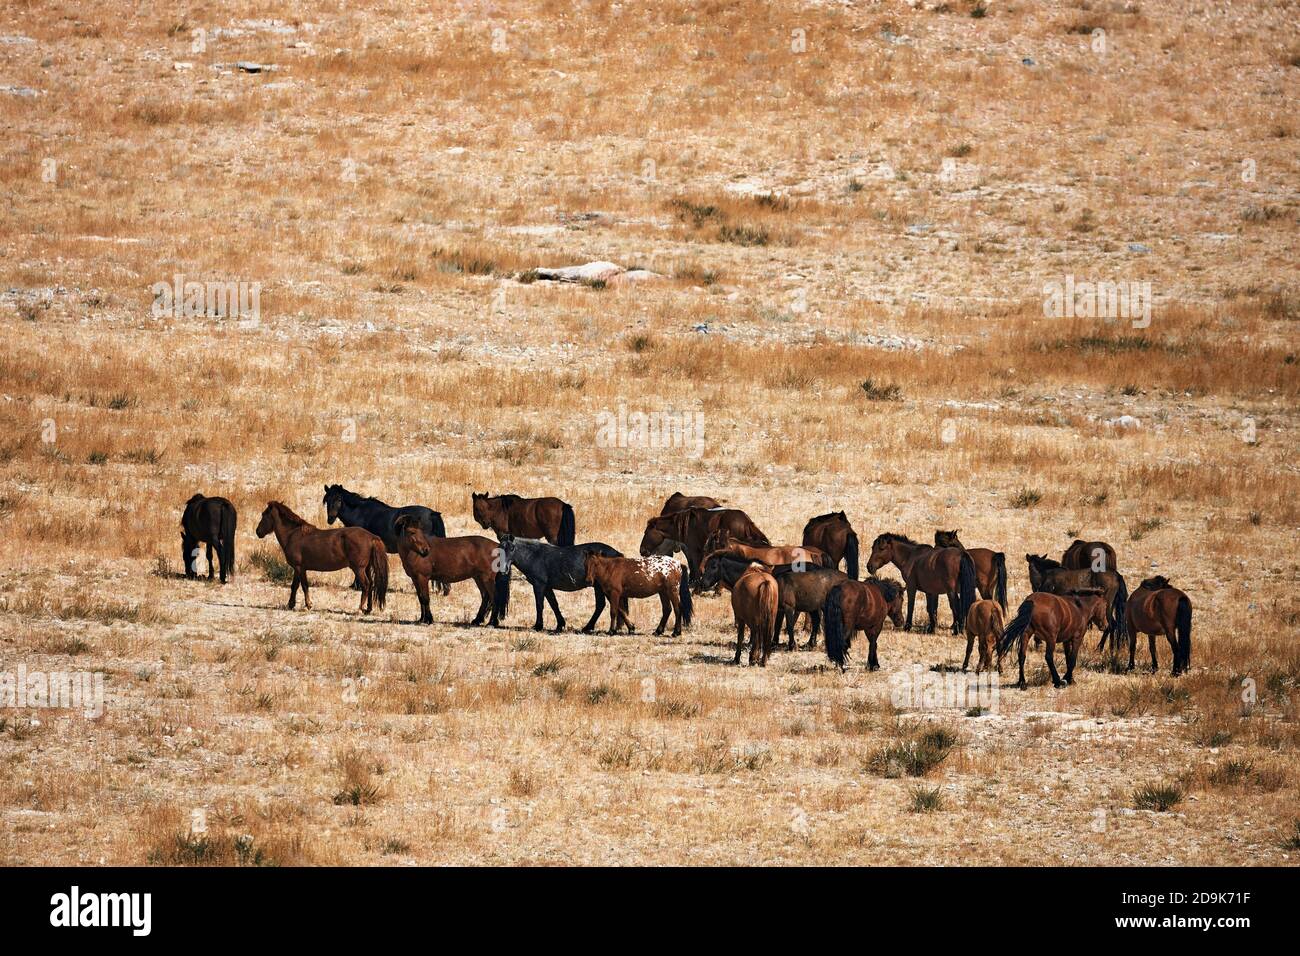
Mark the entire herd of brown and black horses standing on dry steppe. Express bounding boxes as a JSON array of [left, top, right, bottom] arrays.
[[181, 485, 1192, 688]]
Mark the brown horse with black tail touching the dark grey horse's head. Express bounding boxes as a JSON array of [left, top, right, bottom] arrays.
[[394, 515, 510, 627]]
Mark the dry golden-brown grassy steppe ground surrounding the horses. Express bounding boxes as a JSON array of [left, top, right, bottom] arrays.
[[0, 0, 1300, 865]]
